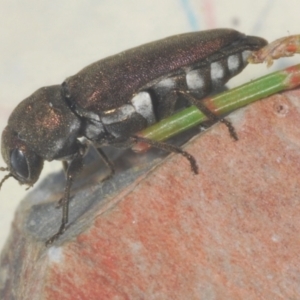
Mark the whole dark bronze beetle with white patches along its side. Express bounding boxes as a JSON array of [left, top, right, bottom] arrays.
[[0, 29, 267, 245]]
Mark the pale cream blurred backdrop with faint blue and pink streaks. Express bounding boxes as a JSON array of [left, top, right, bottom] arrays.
[[0, 0, 300, 249]]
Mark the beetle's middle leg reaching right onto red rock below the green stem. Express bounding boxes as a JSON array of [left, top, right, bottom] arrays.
[[129, 136, 198, 174]]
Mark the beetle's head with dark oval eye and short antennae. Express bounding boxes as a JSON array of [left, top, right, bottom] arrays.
[[0, 126, 44, 187]]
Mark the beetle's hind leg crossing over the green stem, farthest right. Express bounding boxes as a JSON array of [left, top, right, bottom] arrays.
[[177, 91, 238, 141]]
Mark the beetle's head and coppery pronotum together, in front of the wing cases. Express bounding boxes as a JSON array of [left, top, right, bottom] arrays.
[[0, 85, 81, 187]]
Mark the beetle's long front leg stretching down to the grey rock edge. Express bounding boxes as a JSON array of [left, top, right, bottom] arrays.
[[46, 147, 85, 246]]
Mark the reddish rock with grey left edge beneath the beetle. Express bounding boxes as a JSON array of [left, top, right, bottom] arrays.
[[0, 90, 300, 300]]
